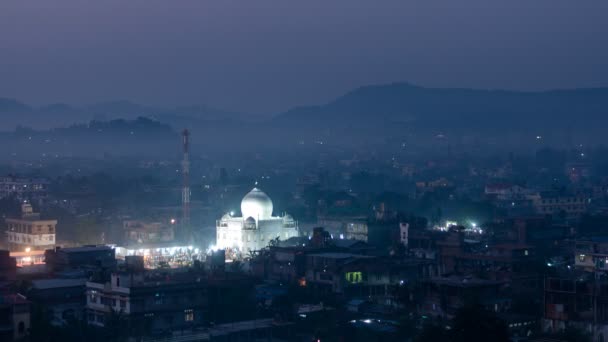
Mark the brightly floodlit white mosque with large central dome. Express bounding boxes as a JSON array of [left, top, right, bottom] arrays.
[[216, 188, 298, 254]]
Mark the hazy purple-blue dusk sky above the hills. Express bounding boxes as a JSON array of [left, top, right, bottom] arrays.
[[0, 0, 608, 112]]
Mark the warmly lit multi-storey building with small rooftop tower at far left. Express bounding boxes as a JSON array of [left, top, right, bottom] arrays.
[[6, 203, 57, 252]]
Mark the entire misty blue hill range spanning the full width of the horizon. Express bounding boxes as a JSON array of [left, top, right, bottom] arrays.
[[0, 83, 608, 153]]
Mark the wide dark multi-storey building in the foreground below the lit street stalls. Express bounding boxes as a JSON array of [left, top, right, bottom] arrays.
[[85, 262, 254, 336]]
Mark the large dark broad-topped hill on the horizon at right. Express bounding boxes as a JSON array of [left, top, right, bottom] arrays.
[[275, 83, 608, 130]]
